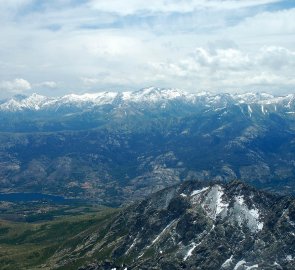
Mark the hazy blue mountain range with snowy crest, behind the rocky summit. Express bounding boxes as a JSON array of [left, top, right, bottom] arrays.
[[0, 87, 295, 205]]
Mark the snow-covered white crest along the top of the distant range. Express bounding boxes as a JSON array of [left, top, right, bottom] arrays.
[[0, 87, 295, 112]]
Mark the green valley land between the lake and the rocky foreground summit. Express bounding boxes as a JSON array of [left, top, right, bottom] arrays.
[[0, 202, 117, 270]]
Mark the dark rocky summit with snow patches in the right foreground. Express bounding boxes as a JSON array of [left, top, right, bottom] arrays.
[[47, 181, 295, 270]]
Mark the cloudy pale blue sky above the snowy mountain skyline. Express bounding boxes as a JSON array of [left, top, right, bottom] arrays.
[[0, 0, 295, 98]]
